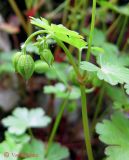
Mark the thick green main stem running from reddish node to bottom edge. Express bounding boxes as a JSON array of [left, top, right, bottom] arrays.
[[80, 85, 94, 160]]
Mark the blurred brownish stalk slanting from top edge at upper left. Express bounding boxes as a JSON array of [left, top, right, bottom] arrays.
[[9, 0, 28, 34]]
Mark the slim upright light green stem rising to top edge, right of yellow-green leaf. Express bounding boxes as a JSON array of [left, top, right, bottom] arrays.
[[86, 0, 96, 61]]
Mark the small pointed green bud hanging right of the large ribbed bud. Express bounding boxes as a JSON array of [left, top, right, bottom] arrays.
[[40, 49, 54, 66]]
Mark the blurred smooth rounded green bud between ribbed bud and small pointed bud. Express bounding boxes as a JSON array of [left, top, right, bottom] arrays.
[[34, 60, 49, 73]]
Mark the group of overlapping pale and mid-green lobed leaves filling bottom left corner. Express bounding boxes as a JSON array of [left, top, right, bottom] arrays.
[[0, 108, 69, 160]]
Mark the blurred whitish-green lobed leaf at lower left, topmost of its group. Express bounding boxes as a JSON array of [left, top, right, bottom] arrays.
[[2, 108, 51, 135]]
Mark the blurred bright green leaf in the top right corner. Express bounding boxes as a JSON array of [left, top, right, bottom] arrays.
[[99, 1, 129, 16]]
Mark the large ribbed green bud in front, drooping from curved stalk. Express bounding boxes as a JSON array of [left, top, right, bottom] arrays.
[[17, 54, 34, 80]]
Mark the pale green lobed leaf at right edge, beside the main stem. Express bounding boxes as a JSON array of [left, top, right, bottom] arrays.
[[80, 55, 129, 85]]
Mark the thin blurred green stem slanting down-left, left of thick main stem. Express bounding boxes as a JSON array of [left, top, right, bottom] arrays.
[[45, 92, 70, 156]]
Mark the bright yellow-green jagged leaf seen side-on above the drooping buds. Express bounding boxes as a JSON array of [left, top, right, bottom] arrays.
[[31, 17, 87, 49]]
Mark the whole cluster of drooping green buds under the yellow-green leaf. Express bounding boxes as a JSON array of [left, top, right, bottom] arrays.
[[13, 43, 54, 80]]
